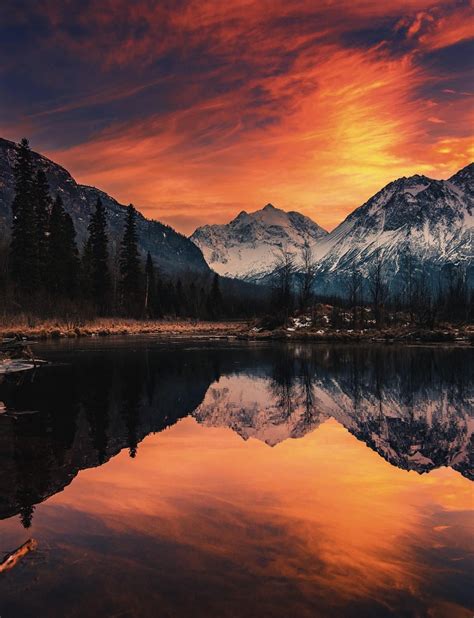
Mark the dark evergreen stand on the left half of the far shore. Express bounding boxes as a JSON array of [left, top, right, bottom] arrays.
[[1, 139, 239, 319]]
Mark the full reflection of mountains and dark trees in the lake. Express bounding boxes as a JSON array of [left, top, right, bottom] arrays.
[[0, 343, 474, 527]]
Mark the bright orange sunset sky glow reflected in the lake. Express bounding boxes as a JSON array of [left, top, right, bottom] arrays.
[[3, 418, 472, 616]]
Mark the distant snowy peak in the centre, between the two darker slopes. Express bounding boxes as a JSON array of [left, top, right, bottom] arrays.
[[191, 204, 327, 282]]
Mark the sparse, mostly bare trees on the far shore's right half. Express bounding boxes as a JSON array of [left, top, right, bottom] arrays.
[[270, 243, 474, 328]]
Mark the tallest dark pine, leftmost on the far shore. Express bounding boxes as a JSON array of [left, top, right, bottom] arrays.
[[10, 139, 39, 294]]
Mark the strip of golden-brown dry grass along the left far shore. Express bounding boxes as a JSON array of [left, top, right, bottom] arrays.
[[0, 316, 248, 339]]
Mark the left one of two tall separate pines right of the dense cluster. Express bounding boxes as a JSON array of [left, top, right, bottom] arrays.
[[85, 197, 110, 313]]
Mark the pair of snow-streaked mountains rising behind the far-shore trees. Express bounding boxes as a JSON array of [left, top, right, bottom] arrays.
[[191, 164, 474, 295]]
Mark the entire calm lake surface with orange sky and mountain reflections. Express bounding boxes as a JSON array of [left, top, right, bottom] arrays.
[[0, 339, 474, 618]]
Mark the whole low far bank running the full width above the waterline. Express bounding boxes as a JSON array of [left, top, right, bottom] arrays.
[[0, 318, 474, 345]]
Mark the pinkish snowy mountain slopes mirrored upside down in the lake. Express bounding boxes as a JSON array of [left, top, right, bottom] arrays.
[[192, 371, 474, 478]]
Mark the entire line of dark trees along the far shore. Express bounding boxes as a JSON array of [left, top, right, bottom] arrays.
[[0, 139, 473, 328]]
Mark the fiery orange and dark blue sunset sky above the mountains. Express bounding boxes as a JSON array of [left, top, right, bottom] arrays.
[[0, 0, 474, 233]]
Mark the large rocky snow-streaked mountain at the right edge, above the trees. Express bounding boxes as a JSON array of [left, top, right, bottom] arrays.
[[317, 164, 474, 293]]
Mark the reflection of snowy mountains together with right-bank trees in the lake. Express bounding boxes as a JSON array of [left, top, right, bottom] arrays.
[[192, 348, 474, 479]]
